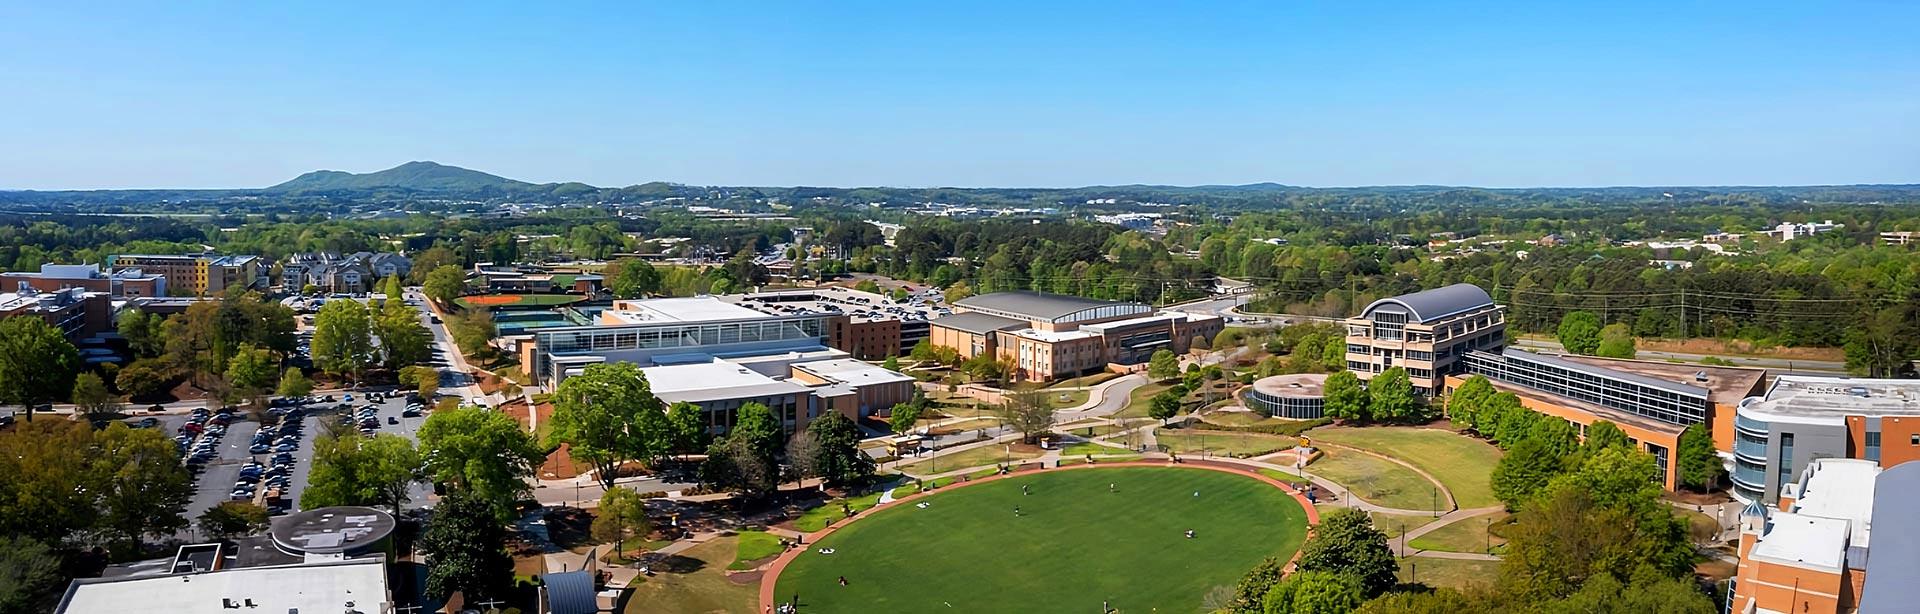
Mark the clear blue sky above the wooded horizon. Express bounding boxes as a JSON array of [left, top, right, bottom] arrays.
[[0, 0, 1920, 188]]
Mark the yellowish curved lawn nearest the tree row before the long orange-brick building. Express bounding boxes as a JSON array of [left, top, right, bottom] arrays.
[[1309, 426, 1500, 508]]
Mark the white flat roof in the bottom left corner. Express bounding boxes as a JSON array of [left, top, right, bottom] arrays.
[[54, 558, 392, 614]]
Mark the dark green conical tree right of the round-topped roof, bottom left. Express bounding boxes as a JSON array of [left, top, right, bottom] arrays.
[[419, 491, 513, 602]]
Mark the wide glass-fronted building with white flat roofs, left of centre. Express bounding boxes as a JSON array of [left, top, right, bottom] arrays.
[[518, 295, 912, 434]]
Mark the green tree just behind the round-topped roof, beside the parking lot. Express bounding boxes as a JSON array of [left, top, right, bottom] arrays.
[[300, 432, 422, 514]]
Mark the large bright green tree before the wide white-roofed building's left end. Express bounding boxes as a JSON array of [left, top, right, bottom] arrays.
[[549, 363, 666, 487]]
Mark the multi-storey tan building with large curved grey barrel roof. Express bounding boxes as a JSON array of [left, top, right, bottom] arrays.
[[1346, 284, 1507, 395]]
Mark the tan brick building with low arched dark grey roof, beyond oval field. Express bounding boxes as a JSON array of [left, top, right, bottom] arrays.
[[929, 292, 1225, 382]]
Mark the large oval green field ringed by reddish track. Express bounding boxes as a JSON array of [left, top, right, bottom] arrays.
[[776, 466, 1306, 612]]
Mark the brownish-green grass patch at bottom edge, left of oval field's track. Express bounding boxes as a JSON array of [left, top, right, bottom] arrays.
[[624, 537, 760, 614]]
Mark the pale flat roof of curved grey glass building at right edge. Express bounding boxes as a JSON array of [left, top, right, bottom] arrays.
[[1740, 376, 1920, 424]]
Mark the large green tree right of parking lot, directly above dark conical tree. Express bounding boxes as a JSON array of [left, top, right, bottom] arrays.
[[420, 407, 547, 520]]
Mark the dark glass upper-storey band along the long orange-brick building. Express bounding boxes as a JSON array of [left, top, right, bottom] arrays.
[[1465, 351, 1707, 426]]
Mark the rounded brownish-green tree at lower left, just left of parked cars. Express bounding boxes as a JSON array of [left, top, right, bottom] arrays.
[[86, 422, 194, 545]]
